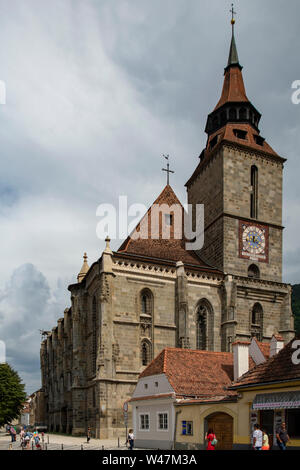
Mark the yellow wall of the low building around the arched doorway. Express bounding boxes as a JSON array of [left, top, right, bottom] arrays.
[[175, 384, 300, 448]]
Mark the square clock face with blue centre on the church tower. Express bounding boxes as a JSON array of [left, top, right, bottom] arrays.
[[239, 221, 269, 262]]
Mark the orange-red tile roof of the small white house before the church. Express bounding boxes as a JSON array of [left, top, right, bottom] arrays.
[[140, 348, 235, 399]]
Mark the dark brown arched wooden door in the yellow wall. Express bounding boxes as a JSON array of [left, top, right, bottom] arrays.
[[207, 413, 233, 450]]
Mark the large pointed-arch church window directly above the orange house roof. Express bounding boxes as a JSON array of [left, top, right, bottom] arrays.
[[196, 299, 213, 351]]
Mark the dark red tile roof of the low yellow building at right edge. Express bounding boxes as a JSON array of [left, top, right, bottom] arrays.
[[232, 338, 300, 388]]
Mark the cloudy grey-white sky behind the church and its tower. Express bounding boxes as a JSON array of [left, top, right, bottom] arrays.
[[0, 0, 300, 393]]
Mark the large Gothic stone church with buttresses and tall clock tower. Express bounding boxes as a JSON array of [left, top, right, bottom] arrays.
[[41, 19, 294, 438]]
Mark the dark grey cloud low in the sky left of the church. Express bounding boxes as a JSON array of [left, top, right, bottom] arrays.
[[0, 264, 67, 392]]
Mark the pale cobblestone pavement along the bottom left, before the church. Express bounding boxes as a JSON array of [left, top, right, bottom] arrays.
[[0, 434, 127, 450]]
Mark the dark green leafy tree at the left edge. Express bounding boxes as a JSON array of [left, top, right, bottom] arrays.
[[0, 363, 26, 427]]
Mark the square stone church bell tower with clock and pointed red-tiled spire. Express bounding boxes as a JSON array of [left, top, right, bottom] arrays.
[[186, 10, 285, 282]]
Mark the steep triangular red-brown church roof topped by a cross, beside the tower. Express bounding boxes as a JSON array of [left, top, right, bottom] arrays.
[[117, 184, 213, 269]]
